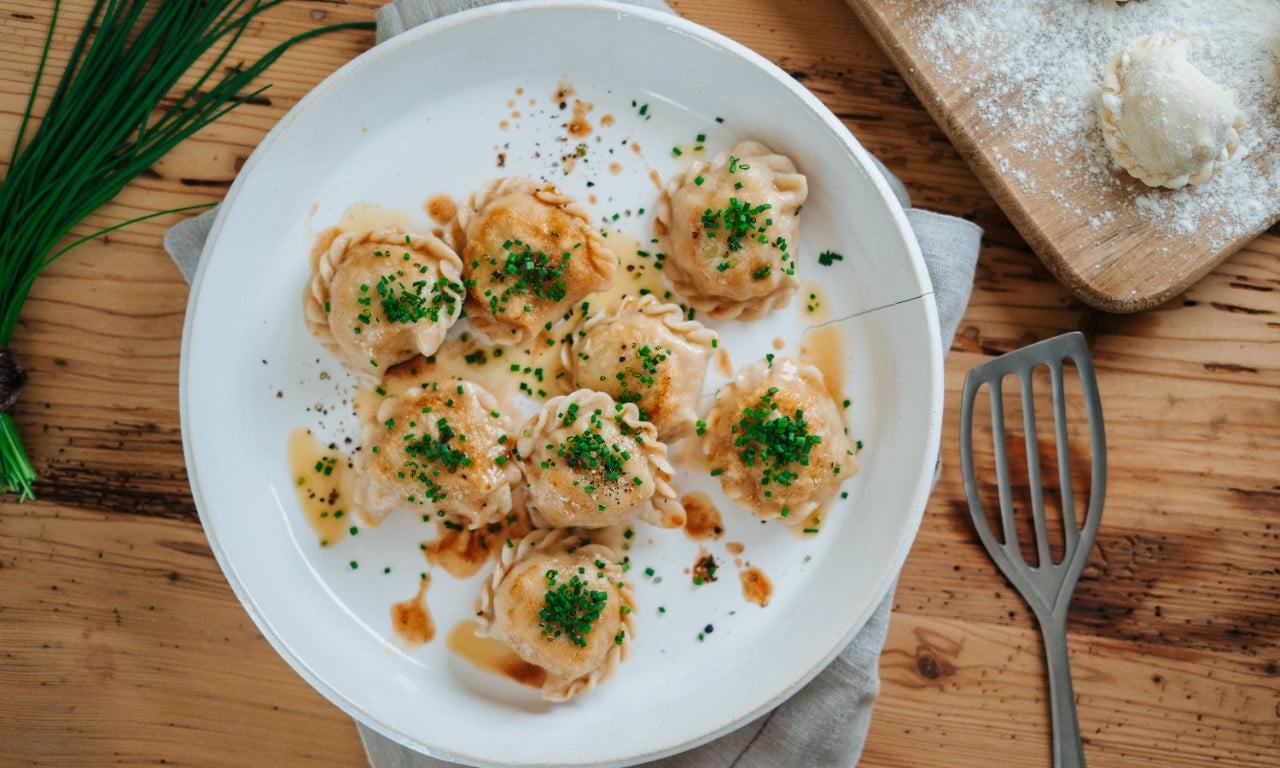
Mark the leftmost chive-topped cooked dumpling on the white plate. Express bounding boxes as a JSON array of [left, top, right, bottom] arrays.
[[305, 229, 466, 381]]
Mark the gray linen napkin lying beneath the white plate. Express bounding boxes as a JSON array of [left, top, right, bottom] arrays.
[[164, 0, 982, 768]]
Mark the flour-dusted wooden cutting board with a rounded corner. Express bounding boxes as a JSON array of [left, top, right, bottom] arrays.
[[847, 0, 1280, 312]]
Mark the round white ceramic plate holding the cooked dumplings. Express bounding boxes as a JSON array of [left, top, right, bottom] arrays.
[[182, 1, 942, 765]]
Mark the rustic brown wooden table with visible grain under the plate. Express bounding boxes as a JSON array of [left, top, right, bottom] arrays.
[[0, 0, 1280, 768]]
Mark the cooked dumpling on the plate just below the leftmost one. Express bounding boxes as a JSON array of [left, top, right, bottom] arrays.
[[355, 381, 520, 530]]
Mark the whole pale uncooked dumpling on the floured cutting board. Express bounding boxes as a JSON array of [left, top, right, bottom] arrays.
[[1098, 32, 1244, 189]]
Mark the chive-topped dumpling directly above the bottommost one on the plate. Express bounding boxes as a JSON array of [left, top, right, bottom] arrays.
[[516, 389, 685, 529]]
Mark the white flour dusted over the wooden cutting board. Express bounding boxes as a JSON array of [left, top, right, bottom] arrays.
[[913, 0, 1280, 248]]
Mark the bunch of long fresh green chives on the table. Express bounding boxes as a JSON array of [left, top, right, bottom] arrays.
[[0, 0, 372, 499]]
